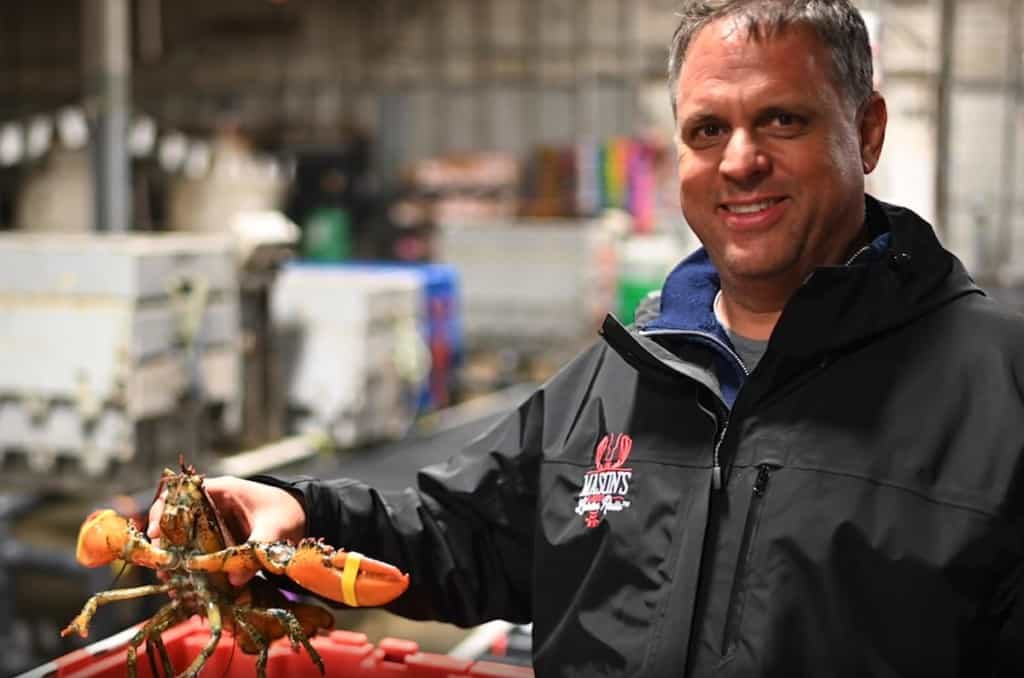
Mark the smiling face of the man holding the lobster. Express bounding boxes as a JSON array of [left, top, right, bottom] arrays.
[[676, 19, 885, 296]]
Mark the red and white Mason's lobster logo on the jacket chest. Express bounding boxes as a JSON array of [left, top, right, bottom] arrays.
[[575, 433, 633, 528]]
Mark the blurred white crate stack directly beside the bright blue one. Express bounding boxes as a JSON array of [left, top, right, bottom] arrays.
[[270, 263, 430, 447]]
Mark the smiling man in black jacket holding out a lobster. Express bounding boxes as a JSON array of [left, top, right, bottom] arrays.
[[151, 0, 1024, 677]]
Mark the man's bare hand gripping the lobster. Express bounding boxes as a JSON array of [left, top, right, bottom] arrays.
[[145, 475, 306, 586]]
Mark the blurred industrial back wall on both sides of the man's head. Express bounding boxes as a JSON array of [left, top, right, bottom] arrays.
[[0, 0, 1024, 282]]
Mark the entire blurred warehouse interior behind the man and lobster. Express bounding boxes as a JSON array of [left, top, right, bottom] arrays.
[[0, 0, 1024, 676]]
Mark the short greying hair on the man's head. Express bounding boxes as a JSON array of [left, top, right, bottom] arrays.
[[669, 0, 873, 118]]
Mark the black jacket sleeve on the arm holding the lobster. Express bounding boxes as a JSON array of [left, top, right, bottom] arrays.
[[254, 388, 545, 626]]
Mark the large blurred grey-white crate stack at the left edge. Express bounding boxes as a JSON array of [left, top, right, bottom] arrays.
[[0, 234, 242, 485]]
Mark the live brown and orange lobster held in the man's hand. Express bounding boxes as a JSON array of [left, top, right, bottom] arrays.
[[60, 461, 409, 678]]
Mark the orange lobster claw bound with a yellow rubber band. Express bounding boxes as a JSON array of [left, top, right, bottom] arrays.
[[257, 539, 409, 607]]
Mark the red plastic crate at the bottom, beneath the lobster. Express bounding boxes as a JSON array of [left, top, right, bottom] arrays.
[[46, 618, 534, 678]]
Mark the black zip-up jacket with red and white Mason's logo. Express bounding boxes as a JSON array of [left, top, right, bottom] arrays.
[[268, 199, 1024, 677]]
